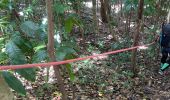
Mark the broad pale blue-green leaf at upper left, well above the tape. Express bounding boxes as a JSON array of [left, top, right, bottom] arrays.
[[20, 21, 39, 37]]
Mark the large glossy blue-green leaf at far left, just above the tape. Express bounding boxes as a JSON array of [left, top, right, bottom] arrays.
[[6, 41, 27, 65]]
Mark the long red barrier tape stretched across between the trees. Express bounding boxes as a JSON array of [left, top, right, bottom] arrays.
[[0, 41, 155, 70]]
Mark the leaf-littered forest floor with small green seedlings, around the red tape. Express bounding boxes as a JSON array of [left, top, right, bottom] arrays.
[[17, 23, 170, 100]]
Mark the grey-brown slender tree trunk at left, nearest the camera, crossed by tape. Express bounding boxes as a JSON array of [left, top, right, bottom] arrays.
[[46, 0, 67, 100]]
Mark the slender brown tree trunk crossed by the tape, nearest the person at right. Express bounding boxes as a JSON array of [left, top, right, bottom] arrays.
[[131, 0, 144, 77]]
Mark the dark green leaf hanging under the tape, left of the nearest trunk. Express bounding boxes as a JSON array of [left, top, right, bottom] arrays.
[[16, 68, 36, 82]]
